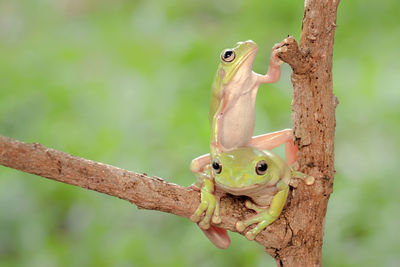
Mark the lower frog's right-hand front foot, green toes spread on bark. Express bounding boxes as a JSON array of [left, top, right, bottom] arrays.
[[236, 200, 277, 240]]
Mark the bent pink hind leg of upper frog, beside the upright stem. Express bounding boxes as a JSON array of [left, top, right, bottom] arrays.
[[248, 129, 297, 166]]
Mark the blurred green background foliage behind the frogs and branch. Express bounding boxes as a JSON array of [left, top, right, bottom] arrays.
[[0, 0, 400, 267]]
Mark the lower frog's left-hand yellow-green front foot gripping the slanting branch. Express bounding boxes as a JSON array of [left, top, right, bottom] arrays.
[[190, 192, 221, 230]]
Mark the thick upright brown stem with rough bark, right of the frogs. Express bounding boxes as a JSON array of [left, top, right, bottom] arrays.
[[267, 0, 339, 266]]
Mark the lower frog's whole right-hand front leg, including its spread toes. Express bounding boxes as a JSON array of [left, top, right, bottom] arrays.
[[236, 182, 289, 240]]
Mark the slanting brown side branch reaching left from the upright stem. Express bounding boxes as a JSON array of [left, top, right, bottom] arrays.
[[0, 136, 291, 248]]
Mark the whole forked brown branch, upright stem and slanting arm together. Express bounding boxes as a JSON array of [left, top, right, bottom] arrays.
[[0, 0, 339, 266]]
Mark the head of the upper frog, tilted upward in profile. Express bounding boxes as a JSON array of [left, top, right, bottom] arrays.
[[218, 40, 258, 84]]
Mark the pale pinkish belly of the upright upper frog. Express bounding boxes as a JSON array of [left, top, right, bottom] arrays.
[[219, 94, 255, 149]]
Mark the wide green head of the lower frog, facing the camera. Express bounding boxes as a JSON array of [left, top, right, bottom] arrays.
[[211, 147, 287, 195]]
